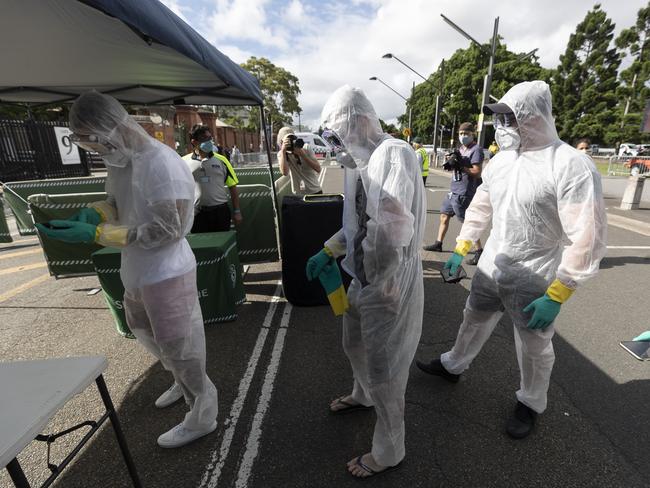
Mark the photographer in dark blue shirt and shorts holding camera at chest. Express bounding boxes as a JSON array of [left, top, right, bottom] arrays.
[[424, 122, 483, 264]]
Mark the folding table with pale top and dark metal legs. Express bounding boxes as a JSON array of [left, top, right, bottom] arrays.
[[0, 356, 141, 488]]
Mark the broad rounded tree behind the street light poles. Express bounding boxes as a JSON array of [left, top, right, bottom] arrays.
[[399, 39, 550, 145]]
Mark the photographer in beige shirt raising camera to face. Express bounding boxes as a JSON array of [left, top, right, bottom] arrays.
[[277, 127, 323, 195]]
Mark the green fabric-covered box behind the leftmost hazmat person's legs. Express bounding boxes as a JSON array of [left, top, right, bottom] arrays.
[[92, 231, 246, 338]]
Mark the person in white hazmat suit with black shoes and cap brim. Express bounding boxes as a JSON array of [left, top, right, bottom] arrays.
[[417, 81, 607, 439]]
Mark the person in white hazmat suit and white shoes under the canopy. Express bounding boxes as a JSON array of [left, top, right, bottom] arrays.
[[39, 91, 218, 447]]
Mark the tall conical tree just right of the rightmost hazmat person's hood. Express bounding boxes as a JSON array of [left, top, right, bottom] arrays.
[[552, 4, 620, 144]]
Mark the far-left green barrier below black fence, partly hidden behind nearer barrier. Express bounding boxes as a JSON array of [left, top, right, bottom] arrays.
[[4, 176, 106, 236]]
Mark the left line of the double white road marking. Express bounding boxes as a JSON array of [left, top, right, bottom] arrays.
[[199, 281, 282, 488]]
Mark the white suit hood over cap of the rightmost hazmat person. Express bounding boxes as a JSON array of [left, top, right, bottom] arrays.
[[499, 80, 560, 152]]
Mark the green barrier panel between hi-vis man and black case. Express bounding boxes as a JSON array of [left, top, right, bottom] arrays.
[[229, 185, 279, 264]]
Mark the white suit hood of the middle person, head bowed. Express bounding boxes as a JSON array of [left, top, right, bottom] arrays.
[[321, 85, 387, 169]]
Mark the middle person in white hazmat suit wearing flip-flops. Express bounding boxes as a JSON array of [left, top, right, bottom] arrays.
[[307, 86, 426, 478]]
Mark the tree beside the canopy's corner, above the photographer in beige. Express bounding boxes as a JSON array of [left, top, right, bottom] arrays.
[[241, 56, 301, 133]]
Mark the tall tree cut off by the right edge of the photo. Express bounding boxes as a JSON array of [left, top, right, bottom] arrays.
[[612, 3, 650, 143]]
